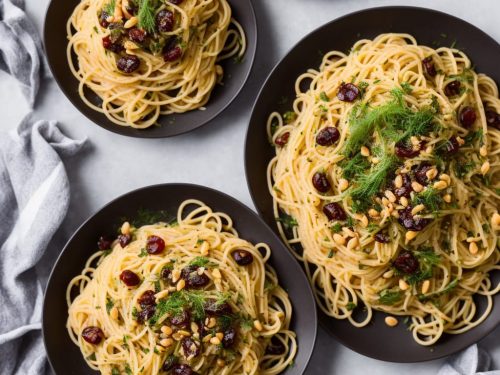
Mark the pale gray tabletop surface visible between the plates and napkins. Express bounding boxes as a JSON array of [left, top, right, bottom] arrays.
[[0, 0, 500, 375]]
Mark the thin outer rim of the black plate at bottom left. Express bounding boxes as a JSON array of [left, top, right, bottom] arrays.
[[41, 182, 318, 374]]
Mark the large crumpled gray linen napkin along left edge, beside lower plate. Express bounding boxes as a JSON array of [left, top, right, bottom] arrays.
[[0, 116, 84, 375]]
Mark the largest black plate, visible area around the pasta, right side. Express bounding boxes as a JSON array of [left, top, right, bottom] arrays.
[[245, 7, 500, 362]]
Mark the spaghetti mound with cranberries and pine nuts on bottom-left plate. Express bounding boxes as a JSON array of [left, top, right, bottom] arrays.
[[67, 200, 297, 375]]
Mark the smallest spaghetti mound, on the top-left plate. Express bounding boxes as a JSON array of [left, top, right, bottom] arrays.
[[67, 0, 245, 129]]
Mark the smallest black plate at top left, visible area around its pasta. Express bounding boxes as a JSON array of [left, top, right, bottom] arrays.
[[44, 0, 257, 138]]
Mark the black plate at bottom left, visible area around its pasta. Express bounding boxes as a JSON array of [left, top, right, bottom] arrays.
[[43, 184, 317, 375]]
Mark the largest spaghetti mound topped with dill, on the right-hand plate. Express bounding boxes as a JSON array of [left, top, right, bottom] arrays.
[[268, 34, 500, 345]]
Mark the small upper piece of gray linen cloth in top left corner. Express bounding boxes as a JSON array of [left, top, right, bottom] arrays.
[[0, 0, 48, 108]]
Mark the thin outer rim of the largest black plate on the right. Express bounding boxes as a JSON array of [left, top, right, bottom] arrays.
[[244, 5, 500, 364]]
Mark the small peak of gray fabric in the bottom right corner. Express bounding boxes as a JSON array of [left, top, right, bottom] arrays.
[[438, 345, 500, 375]]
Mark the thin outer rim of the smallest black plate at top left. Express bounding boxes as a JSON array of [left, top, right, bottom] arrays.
[[41, 0, 259, 139]]
